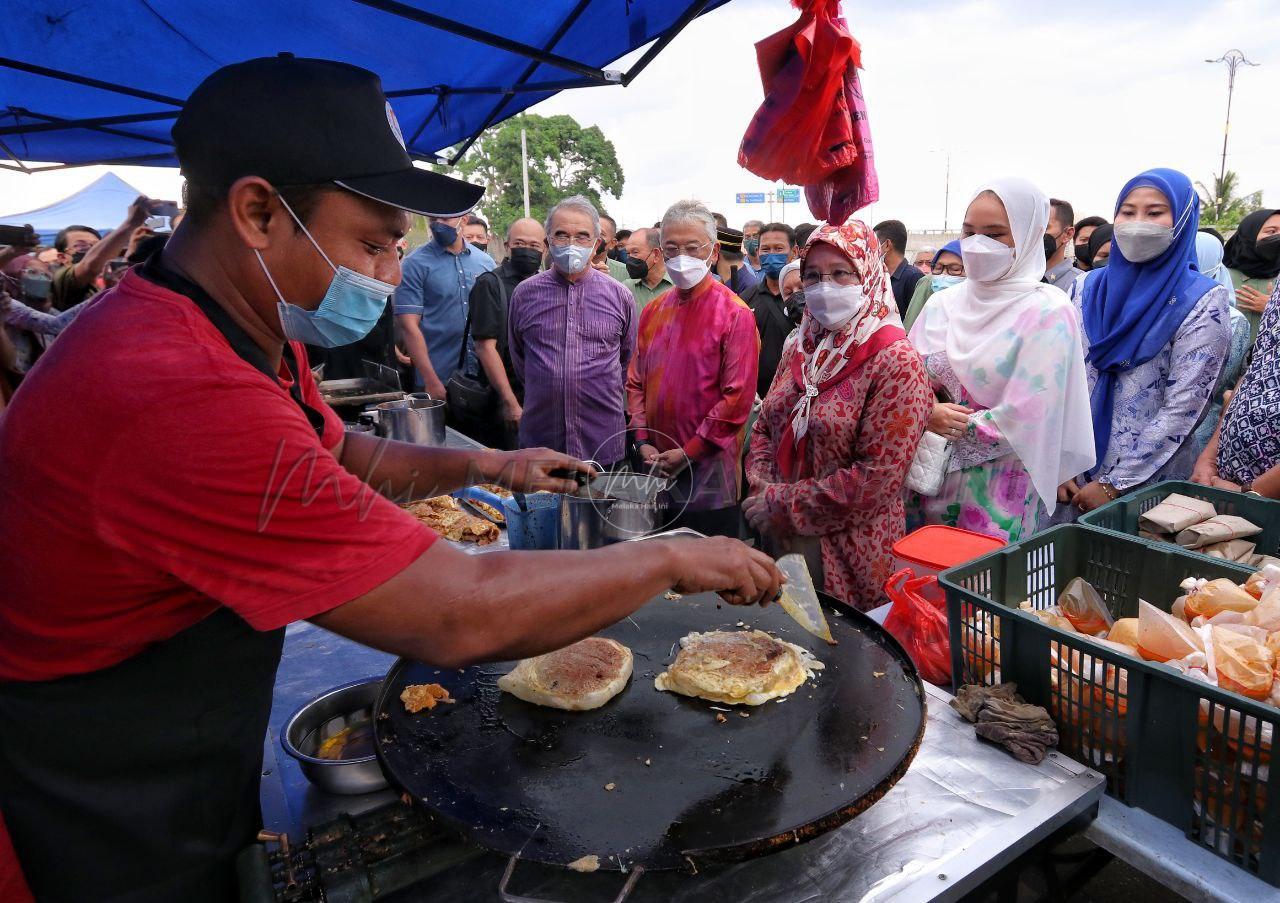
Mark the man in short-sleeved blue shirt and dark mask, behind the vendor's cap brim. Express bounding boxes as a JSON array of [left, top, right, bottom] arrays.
[[394, 213, 494, 398]]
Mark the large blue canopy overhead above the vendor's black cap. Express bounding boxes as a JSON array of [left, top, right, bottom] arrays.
[[0, 0, 728, 172]]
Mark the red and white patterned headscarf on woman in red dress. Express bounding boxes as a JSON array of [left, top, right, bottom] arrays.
[[783, 216, 906, 466]]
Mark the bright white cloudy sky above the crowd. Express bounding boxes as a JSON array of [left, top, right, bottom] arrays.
[[0, 0, 1280, 235]]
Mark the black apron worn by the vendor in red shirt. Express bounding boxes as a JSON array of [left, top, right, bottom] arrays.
[[0, 255, 324, 903]]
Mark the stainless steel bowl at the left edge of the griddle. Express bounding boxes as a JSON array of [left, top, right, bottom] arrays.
[[280, 678, 387, 795]]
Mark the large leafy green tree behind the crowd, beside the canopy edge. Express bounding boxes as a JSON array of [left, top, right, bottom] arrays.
[[438, 113, 625, 232]]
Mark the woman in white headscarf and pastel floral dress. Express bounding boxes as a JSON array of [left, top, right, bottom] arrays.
[[908, 178, 1094, 542]]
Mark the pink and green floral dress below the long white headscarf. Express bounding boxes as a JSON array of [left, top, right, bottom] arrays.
[[906, 351, 1044, 542]]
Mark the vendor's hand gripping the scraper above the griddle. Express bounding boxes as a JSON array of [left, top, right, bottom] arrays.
[[655, 537, 785, 605]]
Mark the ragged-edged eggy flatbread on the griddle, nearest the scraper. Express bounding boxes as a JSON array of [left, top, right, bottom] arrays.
[[653, 630, 823, 706]]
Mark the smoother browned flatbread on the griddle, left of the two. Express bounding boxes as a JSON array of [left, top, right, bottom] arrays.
[[498, 637, 631, 712]]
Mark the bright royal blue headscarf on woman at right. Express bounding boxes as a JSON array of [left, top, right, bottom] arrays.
[[1082, 169, 1217, 466]]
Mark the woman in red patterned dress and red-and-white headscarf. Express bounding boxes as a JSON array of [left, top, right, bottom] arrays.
[[742, 219, 933, 611]]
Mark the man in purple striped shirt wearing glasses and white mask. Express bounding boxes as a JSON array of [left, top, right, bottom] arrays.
[[507, 195, 636, 466]]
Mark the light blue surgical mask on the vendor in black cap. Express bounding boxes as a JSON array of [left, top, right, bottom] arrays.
[[253, 197, 396, 348]]
